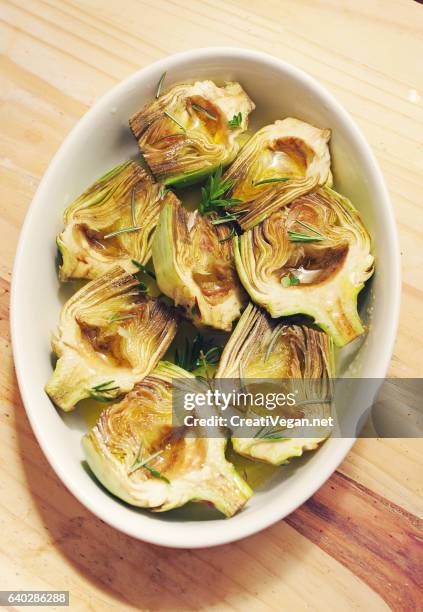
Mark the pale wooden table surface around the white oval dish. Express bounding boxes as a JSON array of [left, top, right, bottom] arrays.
[[0, 0, 423, 611]]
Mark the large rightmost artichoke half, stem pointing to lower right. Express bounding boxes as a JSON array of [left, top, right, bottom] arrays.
[[234, 187, 373, 346]]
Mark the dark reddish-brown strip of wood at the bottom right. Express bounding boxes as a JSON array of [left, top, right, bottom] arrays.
[[286, 473, 423, 610]]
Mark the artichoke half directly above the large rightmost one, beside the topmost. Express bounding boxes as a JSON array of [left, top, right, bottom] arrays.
[[223, 118, 332, 229]]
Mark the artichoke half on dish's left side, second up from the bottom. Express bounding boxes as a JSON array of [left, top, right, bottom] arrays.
[[45, 267, 176, 411]]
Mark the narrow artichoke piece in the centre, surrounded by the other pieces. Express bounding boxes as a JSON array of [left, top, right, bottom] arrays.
[[153, 196, 246, 331]]
